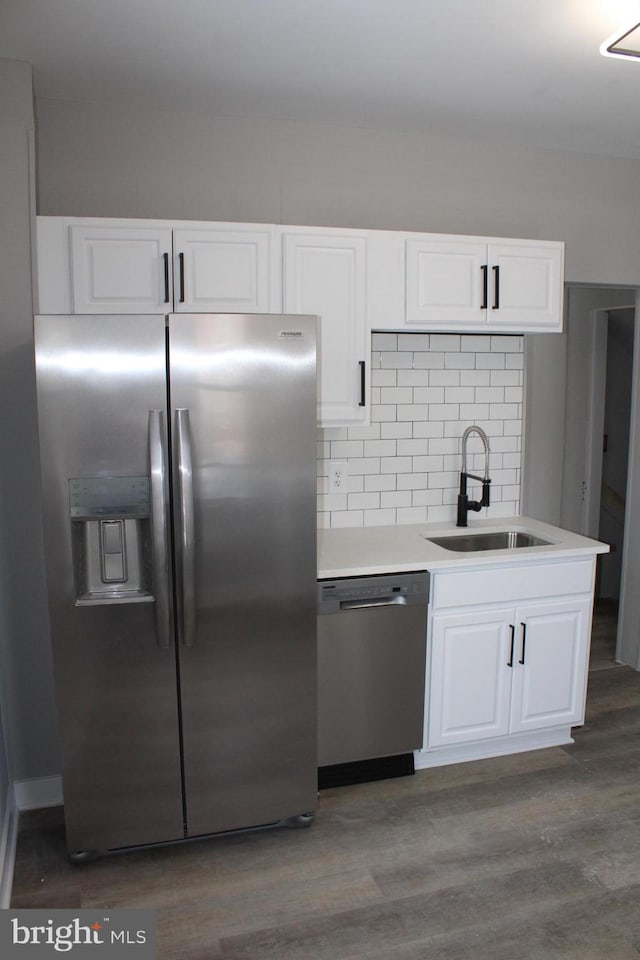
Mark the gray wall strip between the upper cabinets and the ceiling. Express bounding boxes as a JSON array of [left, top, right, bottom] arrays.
[[37, 100, 640, 284]]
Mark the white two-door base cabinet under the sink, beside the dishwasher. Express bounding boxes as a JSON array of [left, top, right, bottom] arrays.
[[419, 560, 594, 766]]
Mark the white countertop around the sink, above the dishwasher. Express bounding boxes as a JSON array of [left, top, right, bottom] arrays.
[[318, 517, 609, 580]]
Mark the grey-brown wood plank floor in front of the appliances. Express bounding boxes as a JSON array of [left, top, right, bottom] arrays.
[[12, 611, 640, 960]]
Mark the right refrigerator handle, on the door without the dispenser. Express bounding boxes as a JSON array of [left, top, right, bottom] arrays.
[[176, 408, 196, 647]]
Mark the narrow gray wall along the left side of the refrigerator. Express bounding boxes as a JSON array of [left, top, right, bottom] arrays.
[[0, 60, 59, 799]]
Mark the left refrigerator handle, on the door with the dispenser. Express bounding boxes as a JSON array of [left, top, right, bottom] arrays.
[[149, 410, 171, 650]]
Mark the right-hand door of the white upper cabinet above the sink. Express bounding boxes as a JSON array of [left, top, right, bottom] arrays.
[[487, 242, 563, 330]]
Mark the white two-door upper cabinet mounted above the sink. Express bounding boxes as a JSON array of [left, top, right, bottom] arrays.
[[405, 234, 564, 333]]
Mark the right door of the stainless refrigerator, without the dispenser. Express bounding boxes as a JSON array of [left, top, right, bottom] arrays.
[[169, 314, 317, 836]]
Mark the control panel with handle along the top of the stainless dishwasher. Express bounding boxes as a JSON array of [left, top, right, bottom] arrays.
[[318, 570, 429, 614]]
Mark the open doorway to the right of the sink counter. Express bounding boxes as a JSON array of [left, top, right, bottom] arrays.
[[561, 287, 640, 669]]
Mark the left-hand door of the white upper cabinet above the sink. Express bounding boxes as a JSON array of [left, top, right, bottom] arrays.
[[406, 237, 487, 330]]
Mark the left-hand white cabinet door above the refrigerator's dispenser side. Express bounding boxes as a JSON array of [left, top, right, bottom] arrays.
[[70, 225, 172, 313]]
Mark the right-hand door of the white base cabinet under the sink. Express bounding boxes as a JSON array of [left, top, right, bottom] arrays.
[[511, 597, 591, 733]]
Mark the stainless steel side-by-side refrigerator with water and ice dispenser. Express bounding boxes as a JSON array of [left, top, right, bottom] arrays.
[[35, 314, 317, 856]]
